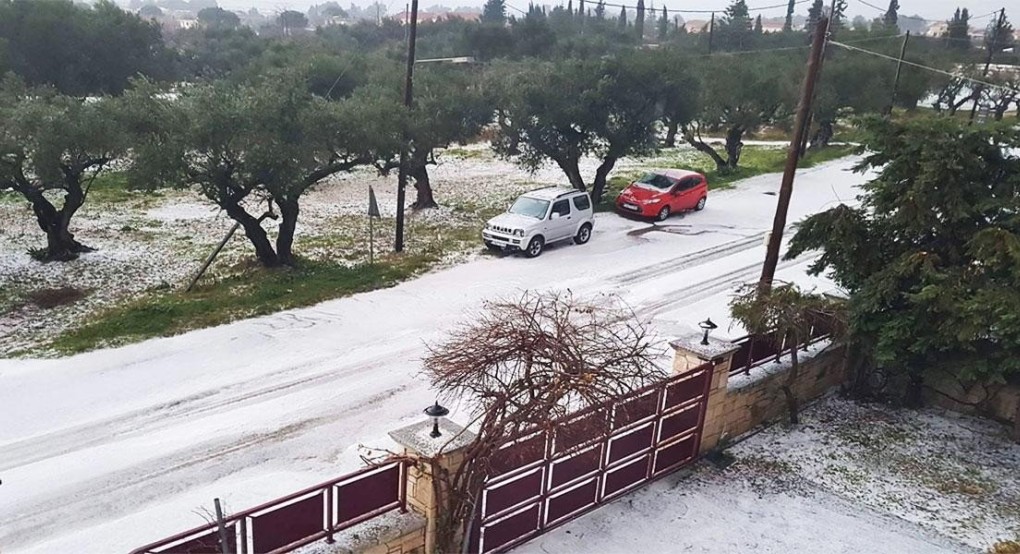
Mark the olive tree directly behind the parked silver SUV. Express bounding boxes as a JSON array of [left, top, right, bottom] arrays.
[[490, 53, 662, 202]]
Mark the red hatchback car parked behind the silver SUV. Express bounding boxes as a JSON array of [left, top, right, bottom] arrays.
[[616, 169, 708, 221]]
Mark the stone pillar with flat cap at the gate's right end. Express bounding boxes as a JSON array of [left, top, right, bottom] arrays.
[[669, 334, 740, 454]]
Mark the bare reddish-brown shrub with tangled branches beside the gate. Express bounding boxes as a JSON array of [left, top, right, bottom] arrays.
[[424, 293, 666, 552]]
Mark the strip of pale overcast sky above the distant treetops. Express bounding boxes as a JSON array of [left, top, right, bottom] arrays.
[[211, 0, 1018, 21]]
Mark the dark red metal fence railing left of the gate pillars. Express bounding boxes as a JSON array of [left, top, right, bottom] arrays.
[[131, 461, 407, 554]]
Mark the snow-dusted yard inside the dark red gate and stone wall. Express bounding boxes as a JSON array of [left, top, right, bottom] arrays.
[[516, 397, 1020, 554]]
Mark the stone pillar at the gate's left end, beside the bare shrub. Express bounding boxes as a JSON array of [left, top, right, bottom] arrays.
[[390, 418, 474, 554]]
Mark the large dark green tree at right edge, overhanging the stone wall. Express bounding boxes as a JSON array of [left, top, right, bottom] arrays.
[[787, 118, 1020, 392]]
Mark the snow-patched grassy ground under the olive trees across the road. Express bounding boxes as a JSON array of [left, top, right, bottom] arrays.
[[0, 144, 848, 357]]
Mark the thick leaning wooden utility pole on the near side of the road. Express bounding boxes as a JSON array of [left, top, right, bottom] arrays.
[[758, 16, 828, 294]]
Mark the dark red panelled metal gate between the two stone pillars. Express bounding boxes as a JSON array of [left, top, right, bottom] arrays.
[[470, 364, 712, 553]]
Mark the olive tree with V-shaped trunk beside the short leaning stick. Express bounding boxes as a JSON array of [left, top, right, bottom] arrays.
[[130, 74, 400, 267]]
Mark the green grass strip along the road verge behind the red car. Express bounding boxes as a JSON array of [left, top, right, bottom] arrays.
[[596, 145, 857, 211]]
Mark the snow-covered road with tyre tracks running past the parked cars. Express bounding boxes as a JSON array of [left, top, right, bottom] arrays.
[[0, 158, 865, 554]]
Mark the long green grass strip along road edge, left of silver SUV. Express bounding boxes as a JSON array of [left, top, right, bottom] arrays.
[[49, 255, 438, 354]]
